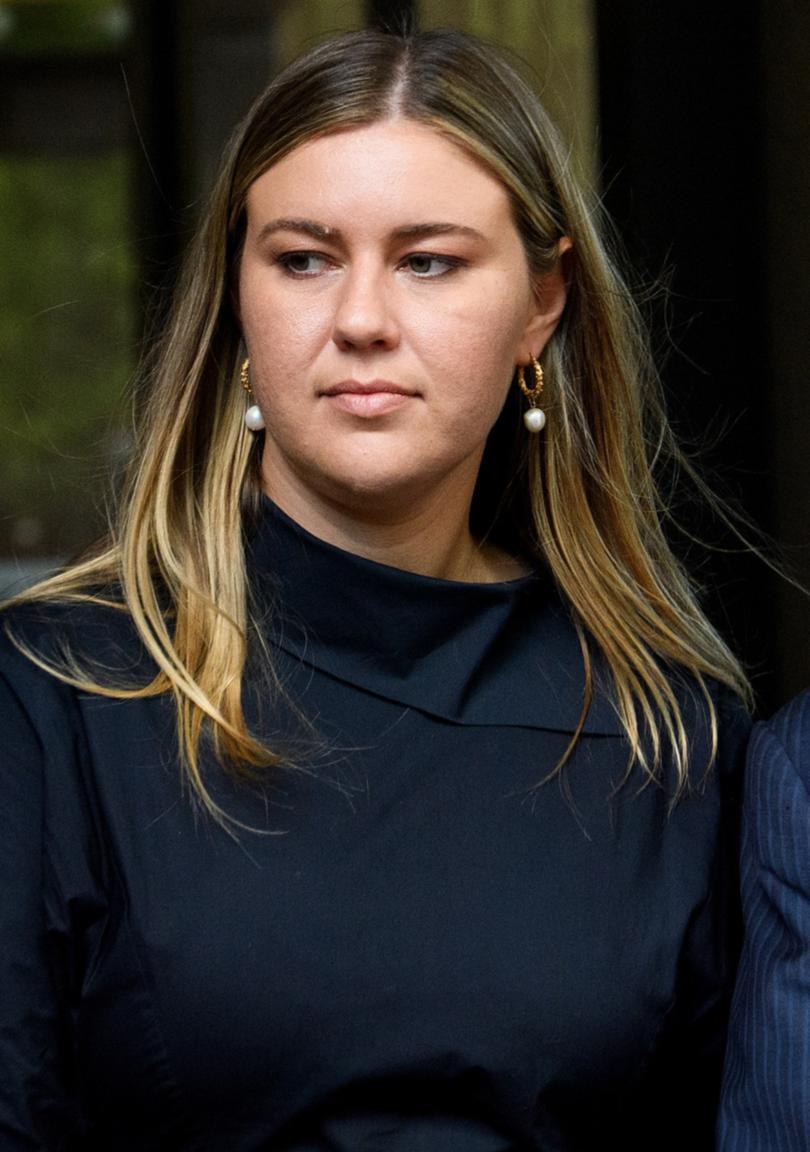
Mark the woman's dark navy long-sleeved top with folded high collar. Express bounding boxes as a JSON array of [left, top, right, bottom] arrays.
[[0, 505, 748, 1152]]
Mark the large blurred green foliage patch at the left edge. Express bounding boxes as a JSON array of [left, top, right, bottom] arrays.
[[0, 153, 137, 555]]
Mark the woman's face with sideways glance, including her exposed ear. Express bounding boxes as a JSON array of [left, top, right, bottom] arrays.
[[239, 120, 565, 513]]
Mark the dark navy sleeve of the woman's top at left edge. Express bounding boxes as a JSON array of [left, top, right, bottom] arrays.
[[0, 639, 103, 1152]]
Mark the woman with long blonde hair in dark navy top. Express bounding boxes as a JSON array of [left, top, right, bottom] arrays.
[[0, 32, 747, 1152]]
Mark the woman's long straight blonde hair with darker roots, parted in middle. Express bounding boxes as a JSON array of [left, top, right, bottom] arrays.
[[7, 31, 749, 821]]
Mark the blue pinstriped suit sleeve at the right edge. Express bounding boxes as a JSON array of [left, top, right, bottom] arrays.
[[719, 692, 810, 1152]]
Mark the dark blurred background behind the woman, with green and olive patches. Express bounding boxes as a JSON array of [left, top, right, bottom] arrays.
[[0, 0, 810, 711]]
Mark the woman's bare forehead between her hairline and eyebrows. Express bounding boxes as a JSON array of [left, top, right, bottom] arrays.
[[248, 119, 510, 228]]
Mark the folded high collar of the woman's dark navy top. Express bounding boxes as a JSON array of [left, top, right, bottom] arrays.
[[249, 498, 621, 734]]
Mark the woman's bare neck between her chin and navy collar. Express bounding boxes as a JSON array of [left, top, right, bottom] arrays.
[[264, 470, 527, 584]]
